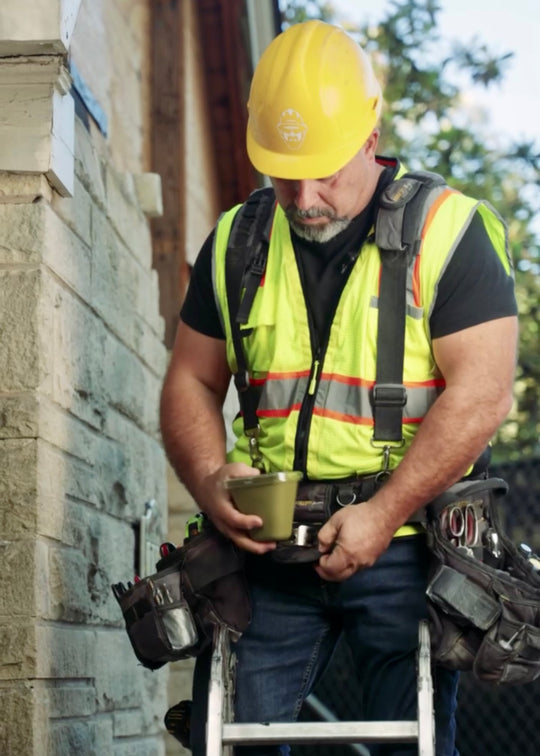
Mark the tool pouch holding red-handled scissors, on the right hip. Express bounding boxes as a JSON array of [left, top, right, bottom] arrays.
[[427, 478, 540, 685]]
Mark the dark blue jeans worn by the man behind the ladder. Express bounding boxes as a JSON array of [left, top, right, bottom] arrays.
[[192, 536, 457, 756]]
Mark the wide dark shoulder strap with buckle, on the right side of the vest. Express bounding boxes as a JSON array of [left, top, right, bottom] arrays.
[[370, 171, 446, 445]]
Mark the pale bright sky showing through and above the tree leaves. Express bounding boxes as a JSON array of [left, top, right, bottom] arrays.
[[332, 0, 540, 149]]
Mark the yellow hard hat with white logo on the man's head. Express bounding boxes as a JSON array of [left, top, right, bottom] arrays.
[[247, 21, 382, 179]]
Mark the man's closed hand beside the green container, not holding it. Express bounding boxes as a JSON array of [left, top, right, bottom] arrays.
[[315, 502, 397, 581]]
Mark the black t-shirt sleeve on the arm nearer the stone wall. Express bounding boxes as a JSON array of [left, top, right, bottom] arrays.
[[180, 231, 225, 339]]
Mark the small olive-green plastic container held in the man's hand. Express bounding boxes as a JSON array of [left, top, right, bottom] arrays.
[[225, 471, 302, 541]]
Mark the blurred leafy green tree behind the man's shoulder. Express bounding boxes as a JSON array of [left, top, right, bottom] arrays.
[[282, 0, 540, 460]]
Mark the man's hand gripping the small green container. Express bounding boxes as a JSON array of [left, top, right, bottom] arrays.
[[201, 462, 276, 554]]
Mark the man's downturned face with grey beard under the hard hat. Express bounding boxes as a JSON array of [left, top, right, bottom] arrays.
[[271, 131, 380, 242]]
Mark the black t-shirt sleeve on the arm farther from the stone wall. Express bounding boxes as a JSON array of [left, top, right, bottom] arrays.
[[429, 213, 517, 339]]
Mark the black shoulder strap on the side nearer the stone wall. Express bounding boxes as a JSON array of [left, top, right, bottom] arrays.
[[225, 188, 275, 433]]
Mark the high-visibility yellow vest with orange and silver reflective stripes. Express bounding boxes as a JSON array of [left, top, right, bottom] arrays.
[[213, 177, 511, 480]]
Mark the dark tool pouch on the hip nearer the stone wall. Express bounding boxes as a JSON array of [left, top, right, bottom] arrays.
[[112, 523, 251, 669]]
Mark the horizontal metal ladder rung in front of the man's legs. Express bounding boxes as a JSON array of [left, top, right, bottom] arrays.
[[222, 721, 418, 745]]
